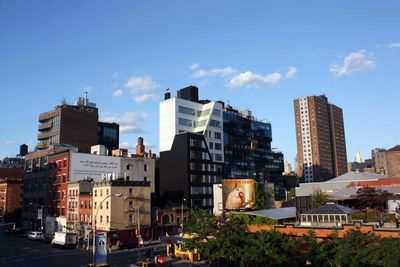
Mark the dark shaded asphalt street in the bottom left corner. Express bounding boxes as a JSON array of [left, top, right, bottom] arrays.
[[0, 234, 166, 267]]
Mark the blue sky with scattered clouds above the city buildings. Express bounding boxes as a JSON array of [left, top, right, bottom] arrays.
[[0, 0, 400, 168]]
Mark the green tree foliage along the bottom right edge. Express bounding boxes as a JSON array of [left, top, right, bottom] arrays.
[[187, 210, 400, 267]]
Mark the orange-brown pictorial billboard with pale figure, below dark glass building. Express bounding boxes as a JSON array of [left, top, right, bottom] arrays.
[[222, 179, 256, 210]]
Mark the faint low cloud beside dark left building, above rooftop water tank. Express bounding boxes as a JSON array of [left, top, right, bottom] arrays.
[[103, 111, 148, 133]]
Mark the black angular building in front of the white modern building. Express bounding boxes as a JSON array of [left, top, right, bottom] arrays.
[[159, 133, 223, 211]]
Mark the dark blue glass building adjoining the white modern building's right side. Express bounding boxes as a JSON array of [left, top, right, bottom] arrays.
[[223, 106, 284, 199]]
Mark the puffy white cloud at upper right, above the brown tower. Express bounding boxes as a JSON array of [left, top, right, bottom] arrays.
[[330, 50, 375, 77]]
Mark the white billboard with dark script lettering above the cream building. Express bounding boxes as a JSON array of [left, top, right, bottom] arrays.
[[69, 152, 121, 181]]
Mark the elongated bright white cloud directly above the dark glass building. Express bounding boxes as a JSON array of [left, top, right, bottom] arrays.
[[228, 71, 282, 87]]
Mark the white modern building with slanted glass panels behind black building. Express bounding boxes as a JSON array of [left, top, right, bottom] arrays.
[[160, 86, 224, 162]]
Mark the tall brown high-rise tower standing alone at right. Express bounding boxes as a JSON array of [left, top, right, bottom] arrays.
[[294, 95, 347, 182]]
